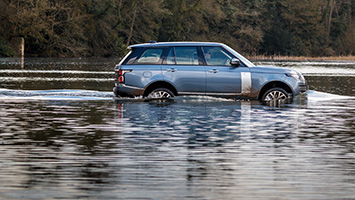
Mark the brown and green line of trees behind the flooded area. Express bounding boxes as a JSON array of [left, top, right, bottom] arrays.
[[0, 0, 355, 57]]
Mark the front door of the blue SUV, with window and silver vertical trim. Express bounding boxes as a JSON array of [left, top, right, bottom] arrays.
[[201, 46, 251, 96]]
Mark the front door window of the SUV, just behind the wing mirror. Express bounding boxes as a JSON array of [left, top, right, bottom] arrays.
[[202, 47, 233, 66]]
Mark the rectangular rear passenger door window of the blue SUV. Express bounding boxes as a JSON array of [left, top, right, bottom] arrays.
[[175, 47, 199, 65]]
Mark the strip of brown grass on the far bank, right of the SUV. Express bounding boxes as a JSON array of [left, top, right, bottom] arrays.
[[248, 55, 355, 61]]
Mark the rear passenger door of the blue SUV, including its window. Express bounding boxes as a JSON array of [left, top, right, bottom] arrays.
[[162, 46, 206, 95]]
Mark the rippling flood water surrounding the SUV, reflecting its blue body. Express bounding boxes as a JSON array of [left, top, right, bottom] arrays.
[[0, 58, 355, 200]]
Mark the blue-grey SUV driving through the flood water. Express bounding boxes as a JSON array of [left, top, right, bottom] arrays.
[[113, 42, 307, 101]]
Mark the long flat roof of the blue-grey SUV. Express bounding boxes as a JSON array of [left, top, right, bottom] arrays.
[[128, 42, 224, 49]]
